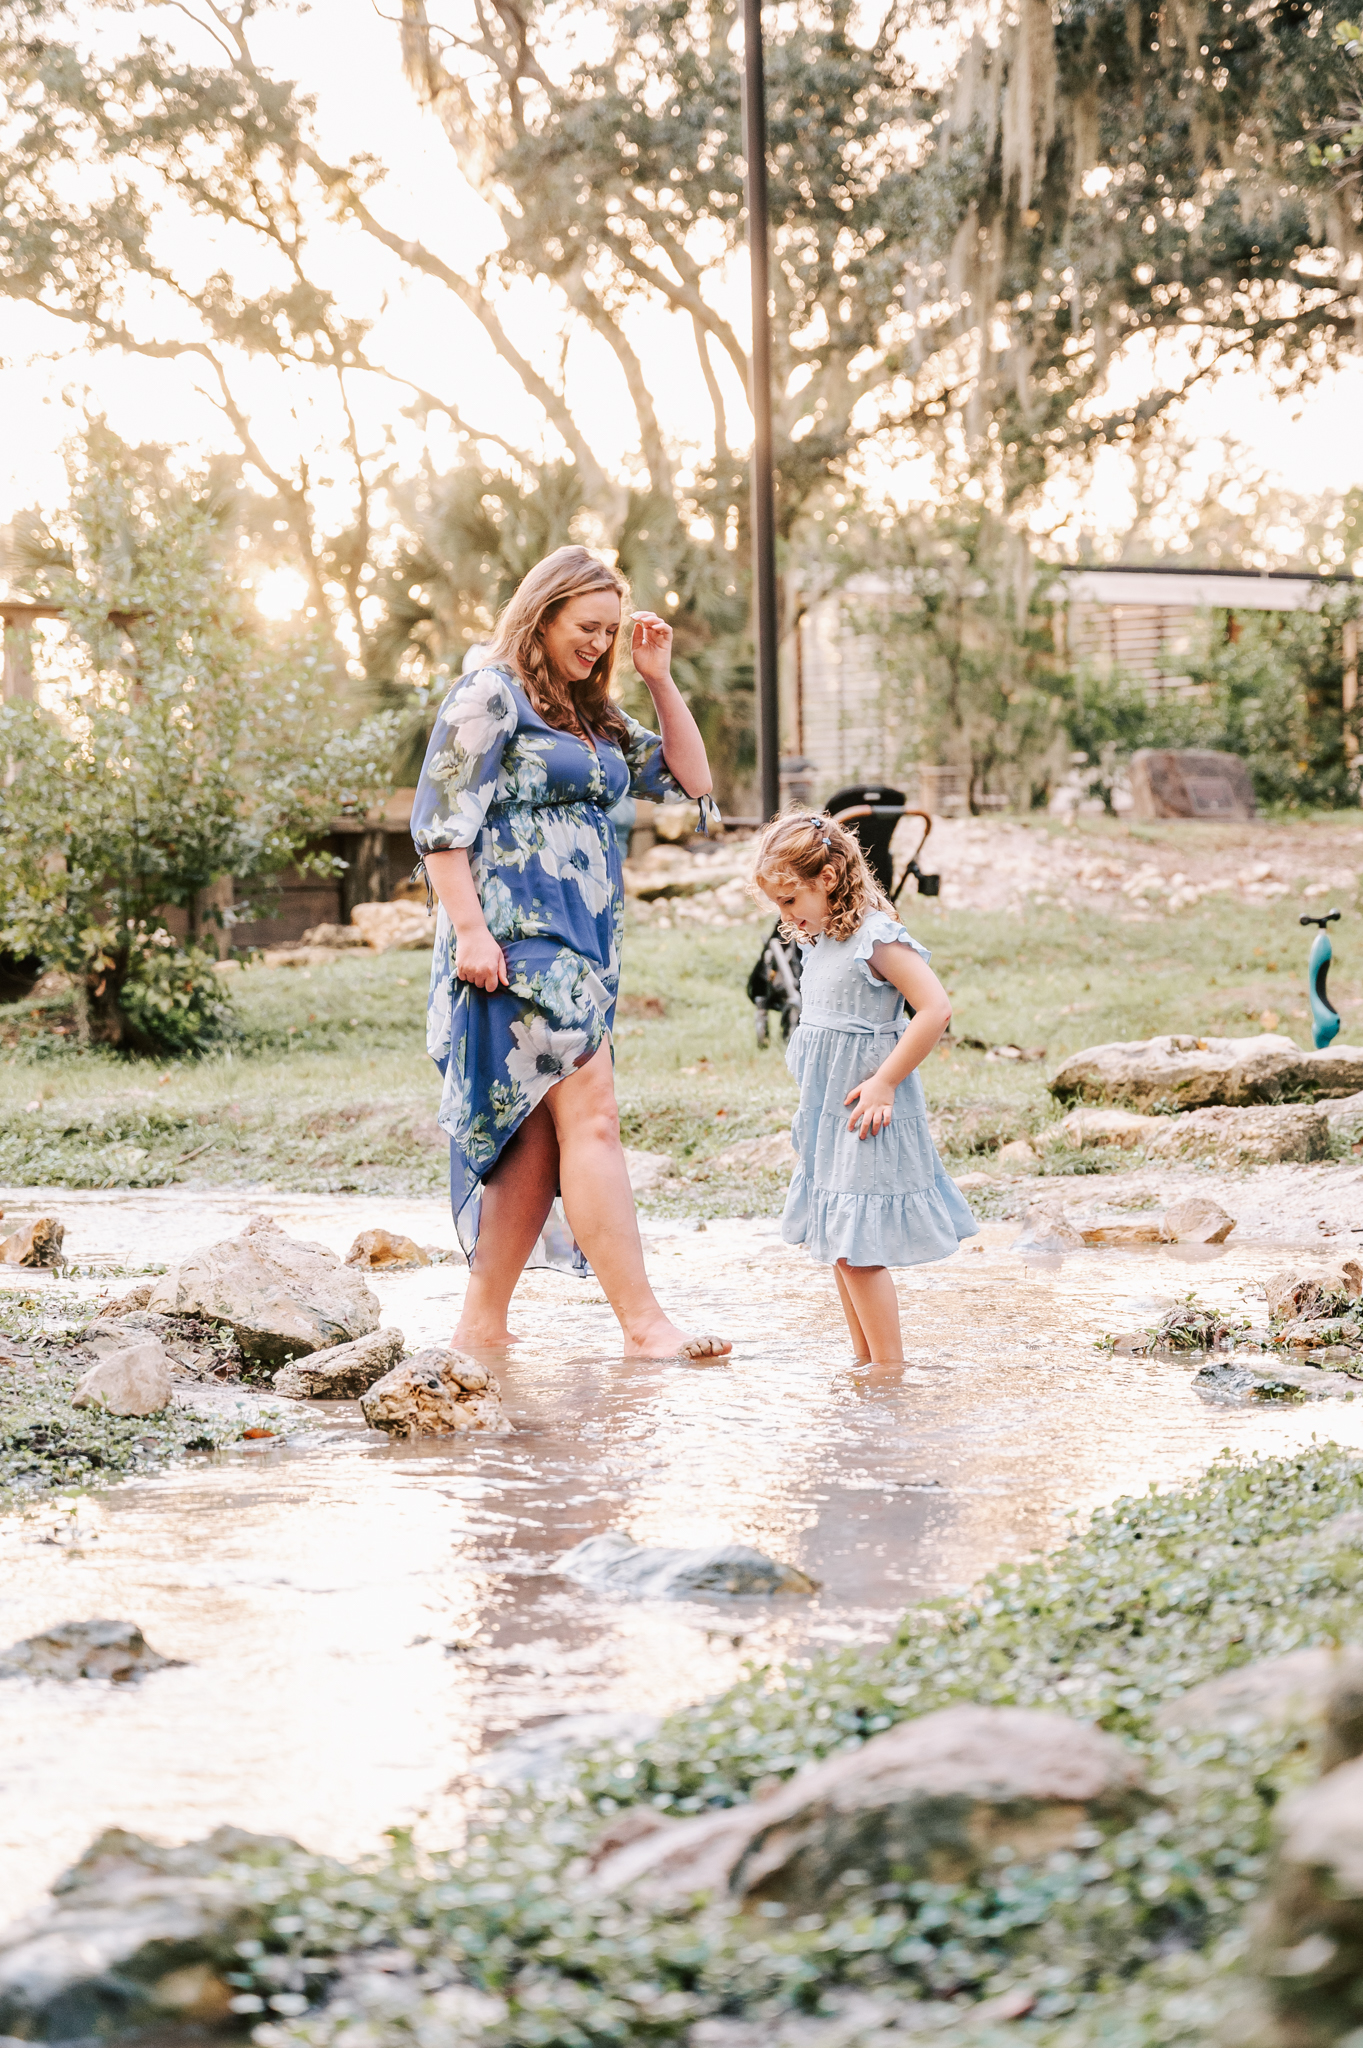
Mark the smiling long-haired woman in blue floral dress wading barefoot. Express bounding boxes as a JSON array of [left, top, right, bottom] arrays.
[[411, 547, 729, 1358]]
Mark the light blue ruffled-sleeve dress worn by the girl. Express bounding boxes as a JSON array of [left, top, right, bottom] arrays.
[[782, 909, 976, 1266]]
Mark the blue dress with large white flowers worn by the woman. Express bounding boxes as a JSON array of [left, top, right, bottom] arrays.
[[411, 668, 684, 1272]]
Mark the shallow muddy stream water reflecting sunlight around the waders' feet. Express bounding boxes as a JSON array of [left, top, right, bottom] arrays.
[[0, 1190, 1363, 1917]]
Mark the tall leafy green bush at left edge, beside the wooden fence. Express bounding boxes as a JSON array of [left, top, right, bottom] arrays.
[[0, 440, 393, 1053]]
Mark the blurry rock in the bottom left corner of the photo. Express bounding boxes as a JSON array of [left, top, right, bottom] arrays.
[[0, 1827, 299, 2042]]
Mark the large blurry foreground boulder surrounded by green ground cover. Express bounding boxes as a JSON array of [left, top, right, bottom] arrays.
[[598, 1706, 1148, 1913]]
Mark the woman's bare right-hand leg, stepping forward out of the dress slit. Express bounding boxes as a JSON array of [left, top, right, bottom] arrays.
[[544, 1044, 731, 1358]]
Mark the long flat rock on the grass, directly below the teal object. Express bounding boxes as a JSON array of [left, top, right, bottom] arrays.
[[1050, 1032, 1363, 1110]]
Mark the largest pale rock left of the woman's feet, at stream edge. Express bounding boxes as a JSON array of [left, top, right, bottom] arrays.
[[147, 1217, 381, 1366]]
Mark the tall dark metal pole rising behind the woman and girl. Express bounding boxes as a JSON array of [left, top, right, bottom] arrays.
[[743, 0, 782, 817]]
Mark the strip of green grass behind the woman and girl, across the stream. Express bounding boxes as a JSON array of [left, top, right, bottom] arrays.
[[0, 897, 1363, 1210]]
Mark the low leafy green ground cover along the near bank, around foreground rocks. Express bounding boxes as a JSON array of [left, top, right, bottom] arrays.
[[127, 1446, 1363, 2048]]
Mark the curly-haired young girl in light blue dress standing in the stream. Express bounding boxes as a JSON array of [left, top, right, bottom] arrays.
[[753, 813, 976, 1364]]
